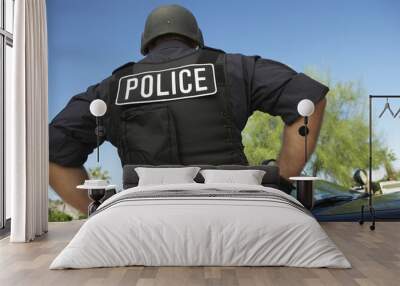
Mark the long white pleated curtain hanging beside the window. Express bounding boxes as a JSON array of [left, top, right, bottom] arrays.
[[6, 0, 48, 242]]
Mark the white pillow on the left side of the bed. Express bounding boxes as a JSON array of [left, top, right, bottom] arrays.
[[135, 167, 200, 186]]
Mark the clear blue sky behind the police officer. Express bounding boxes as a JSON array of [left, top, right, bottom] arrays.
[[47, 0, 400, 188]]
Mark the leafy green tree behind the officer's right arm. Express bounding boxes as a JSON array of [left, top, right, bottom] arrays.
[[243, 73, 395, 186]]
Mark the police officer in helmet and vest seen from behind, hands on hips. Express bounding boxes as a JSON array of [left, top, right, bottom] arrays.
[[50, 5, 328, 211]]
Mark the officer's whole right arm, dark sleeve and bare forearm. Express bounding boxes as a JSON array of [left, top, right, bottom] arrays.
[[248, 57, 329, 178]]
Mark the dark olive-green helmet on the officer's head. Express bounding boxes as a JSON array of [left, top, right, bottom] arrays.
[[141, 5, 204, 55]]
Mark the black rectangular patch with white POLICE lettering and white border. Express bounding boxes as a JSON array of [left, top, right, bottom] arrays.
[[115, 64, 217, 105]]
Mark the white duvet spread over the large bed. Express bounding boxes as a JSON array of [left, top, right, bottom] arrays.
[[50, 183, 351, 269]]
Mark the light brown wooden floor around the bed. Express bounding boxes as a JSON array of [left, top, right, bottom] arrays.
[[0, 221, 400, 286]]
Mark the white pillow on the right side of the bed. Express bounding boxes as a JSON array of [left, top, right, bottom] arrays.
[[200, 170, 265, 185]]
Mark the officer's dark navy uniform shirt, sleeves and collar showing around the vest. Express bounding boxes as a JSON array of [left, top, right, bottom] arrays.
[[49, 40, 328, 167]]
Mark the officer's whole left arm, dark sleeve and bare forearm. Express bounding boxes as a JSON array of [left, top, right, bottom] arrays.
[[49, 81, 105, 213]]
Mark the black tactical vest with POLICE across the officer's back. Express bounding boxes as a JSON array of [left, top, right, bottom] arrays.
[[105, 48, 248, 165]]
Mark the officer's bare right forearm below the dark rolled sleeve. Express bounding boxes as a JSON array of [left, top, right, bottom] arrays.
[[278, 99, 326, 178]]
